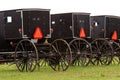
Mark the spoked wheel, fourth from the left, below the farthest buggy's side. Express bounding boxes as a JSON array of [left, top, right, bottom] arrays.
[[91, 38, 113, 65]]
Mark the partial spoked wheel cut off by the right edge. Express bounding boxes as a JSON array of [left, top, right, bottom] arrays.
[[110, 40, 120, 64]]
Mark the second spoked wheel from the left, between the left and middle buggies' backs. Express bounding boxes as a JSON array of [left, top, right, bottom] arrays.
[[50, 39, 72, 71]]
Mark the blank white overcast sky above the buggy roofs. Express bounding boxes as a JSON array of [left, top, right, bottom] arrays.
[[0, 0, 120, 16]]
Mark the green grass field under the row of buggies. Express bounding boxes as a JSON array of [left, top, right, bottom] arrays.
[[0, 65, 120, 80]]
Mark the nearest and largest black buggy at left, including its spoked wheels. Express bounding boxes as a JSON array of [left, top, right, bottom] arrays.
[[0, 9, 71, 72]]
